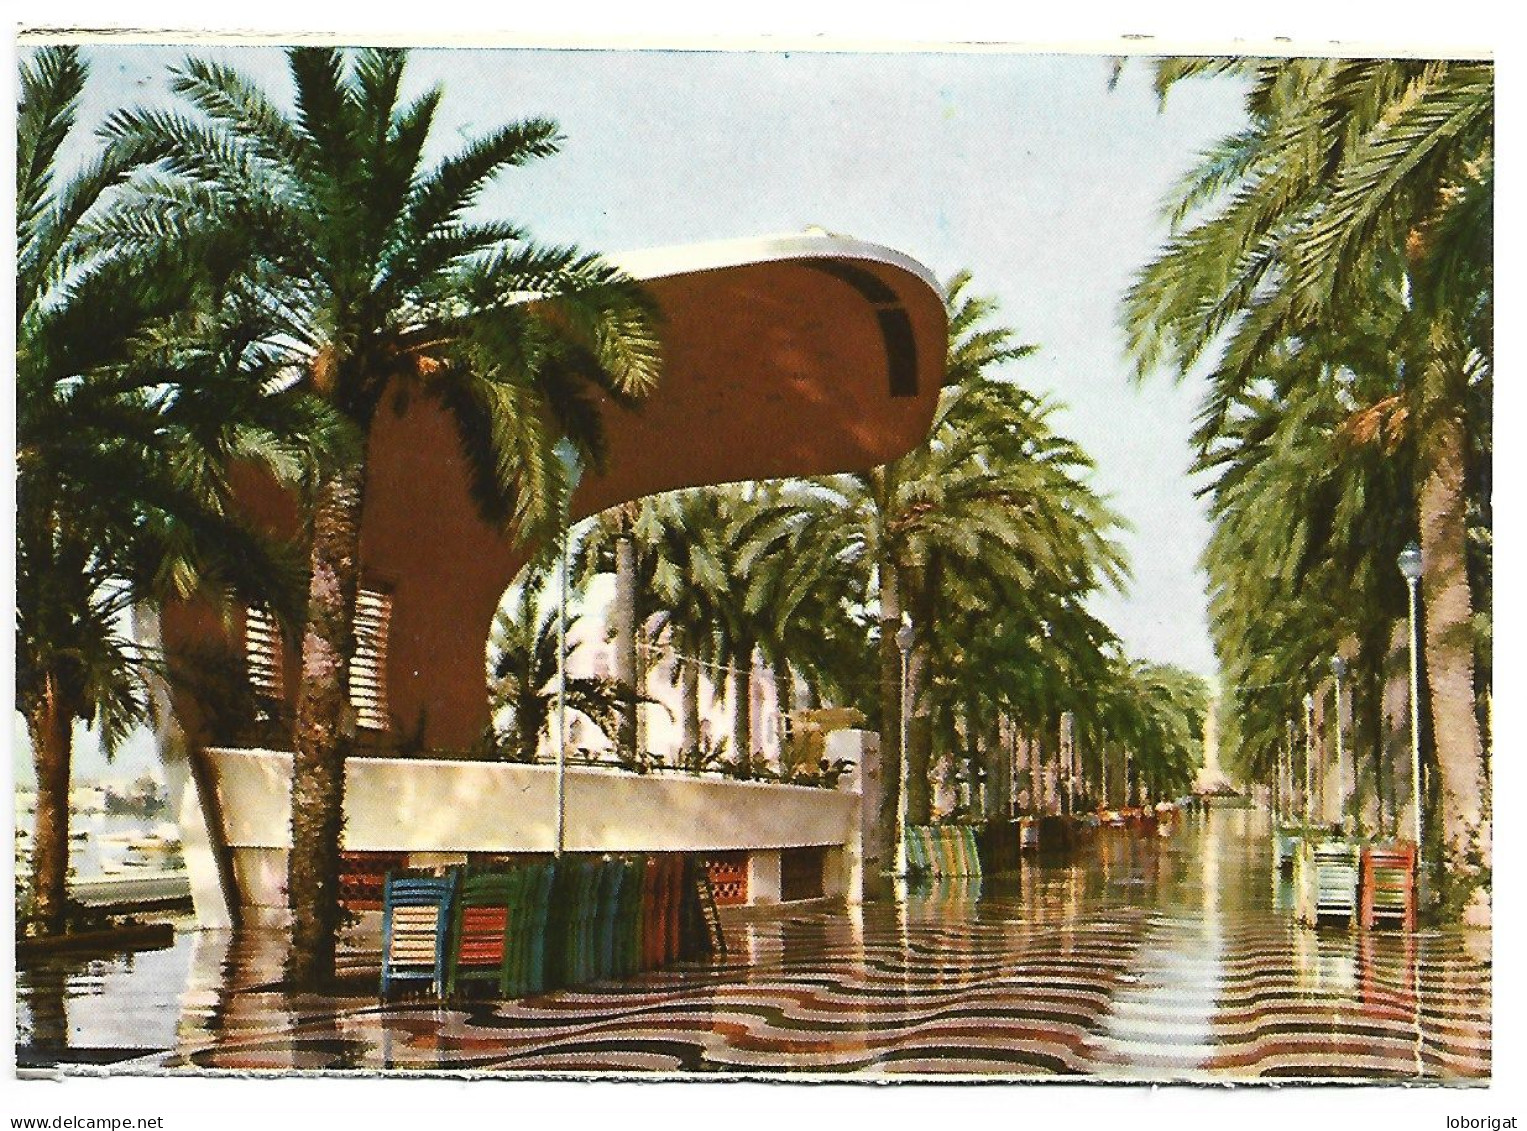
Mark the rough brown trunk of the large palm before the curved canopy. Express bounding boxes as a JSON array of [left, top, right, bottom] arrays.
[[287, 464, 365, 991]]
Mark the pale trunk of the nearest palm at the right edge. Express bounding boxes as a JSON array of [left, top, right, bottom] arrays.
[[1419, 398, 1490, 922]]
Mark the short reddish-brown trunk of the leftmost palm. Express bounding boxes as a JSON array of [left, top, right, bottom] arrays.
[[26, 672, 73, 934]]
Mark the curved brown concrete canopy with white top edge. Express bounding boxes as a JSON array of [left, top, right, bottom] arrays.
[[163, 234, 947, 749]]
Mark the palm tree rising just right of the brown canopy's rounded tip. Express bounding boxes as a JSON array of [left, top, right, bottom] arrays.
[[805, 275, 1124, 852]]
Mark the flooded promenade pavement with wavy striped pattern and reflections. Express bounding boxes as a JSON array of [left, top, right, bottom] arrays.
[[18, 810, 1490, 1082]]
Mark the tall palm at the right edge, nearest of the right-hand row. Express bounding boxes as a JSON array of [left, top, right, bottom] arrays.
[[1127, 60, 1495, 914]]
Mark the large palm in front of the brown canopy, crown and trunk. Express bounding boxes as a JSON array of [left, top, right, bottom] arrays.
[[99, 47, 658, 988]]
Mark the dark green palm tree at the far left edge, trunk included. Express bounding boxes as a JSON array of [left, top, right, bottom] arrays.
[[15, 47, 333, 933]]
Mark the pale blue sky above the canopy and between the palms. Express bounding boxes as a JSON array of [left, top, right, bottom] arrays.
[[23, 46, 1240, 787]]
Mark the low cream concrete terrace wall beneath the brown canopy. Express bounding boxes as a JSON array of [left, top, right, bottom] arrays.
[[206, 749, 861, 917]]
